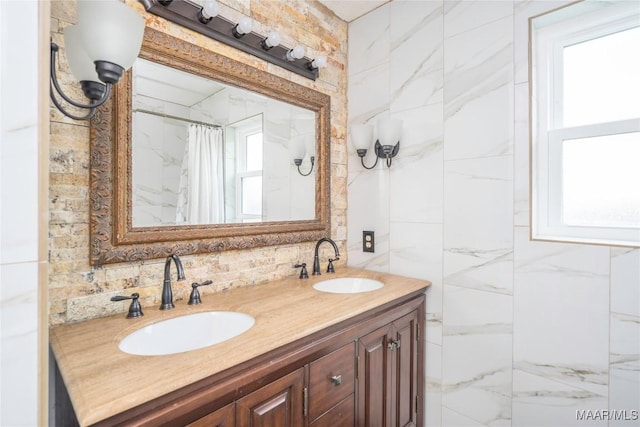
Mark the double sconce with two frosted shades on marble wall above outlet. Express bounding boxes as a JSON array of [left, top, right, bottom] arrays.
[[351, 119, 402, 169]]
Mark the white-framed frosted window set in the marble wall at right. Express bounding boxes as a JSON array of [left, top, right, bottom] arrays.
[[530, 1, 640, 246]]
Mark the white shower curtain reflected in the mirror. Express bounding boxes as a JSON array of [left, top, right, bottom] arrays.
[[176, 124, 224, 224]]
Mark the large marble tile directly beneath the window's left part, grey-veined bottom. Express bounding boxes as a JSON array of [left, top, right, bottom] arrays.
[[513, 227, 609, 395]]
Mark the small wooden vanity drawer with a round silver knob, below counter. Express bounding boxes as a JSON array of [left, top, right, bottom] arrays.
[[309, 342, 355, 420]]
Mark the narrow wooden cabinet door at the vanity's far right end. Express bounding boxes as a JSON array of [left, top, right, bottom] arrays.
[[387, 311, 422, 427]]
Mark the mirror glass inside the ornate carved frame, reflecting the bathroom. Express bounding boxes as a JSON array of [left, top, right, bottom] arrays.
[[131, 58, 316, 231]]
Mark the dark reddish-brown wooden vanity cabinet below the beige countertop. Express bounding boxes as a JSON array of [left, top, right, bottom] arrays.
[[84, 292, 425, 427]]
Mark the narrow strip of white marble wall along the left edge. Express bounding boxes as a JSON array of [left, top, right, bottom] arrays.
[[0, 1, 46, 426]]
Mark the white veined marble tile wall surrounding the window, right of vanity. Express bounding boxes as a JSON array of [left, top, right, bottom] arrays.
[[348, 0, 640, 427]]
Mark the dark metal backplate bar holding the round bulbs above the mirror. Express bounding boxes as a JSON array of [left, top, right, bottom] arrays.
[[139, 0, 319, 80]]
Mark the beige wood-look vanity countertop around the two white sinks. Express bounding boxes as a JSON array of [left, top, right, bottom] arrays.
[[49, 267, 430, 426]]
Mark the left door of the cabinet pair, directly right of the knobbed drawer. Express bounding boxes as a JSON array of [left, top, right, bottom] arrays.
[[358, 325, 392, 427]]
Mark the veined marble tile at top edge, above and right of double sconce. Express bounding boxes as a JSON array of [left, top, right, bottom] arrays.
[[389, 1, 443, 110]]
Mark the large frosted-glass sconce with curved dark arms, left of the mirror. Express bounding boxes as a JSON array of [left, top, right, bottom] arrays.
[[50, 0, 144, 120]]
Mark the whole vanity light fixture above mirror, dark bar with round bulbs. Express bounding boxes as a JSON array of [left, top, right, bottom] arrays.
[[138, 0, 327, 80]]
